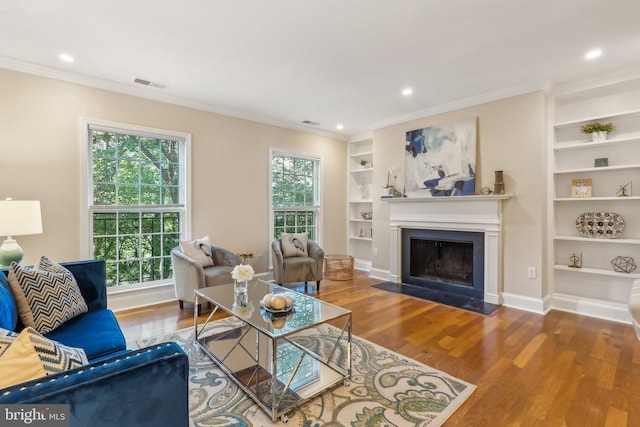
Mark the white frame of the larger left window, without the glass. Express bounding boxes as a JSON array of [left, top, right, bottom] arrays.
[[80, 117, 191, 294]]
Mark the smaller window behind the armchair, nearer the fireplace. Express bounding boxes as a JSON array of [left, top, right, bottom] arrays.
[[271, 152, 320, 241]]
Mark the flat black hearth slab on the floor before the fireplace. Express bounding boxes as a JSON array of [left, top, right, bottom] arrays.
[[372, 282, 500, 314]]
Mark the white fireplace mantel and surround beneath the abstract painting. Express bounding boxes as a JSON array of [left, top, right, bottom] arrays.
[[382, 194, 511, 304]]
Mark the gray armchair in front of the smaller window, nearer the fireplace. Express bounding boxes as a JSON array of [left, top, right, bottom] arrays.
[[271, 239, 324, 292]]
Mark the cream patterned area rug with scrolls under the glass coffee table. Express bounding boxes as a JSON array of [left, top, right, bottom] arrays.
[[138, 318, 475, 427]]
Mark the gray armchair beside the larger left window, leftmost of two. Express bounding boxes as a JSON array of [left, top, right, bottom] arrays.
[[171, 246, 240, 310]]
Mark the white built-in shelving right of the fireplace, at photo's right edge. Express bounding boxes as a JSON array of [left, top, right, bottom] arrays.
[[550, 79, 640, 320]]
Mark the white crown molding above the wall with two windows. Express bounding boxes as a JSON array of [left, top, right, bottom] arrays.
[[0, 57, 348, 141]]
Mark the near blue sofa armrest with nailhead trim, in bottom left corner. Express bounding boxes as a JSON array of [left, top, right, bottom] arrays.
[[0, 343, 189, 427]]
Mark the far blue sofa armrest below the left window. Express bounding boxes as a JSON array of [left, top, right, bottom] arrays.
[[60, 259, 107, 311]]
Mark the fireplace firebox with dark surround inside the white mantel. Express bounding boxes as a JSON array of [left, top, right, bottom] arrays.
[[401, 228, 484, 299]]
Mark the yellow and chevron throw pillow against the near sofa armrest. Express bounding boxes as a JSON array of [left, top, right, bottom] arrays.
[[0, 328, 89, 388]]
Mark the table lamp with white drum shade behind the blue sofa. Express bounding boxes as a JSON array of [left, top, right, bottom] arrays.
[[0, 198, 42, 267]]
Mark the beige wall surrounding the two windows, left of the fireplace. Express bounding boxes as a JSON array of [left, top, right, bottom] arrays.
[[0, 69, 347, 271]]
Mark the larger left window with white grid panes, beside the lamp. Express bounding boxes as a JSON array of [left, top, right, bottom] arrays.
[[87, 120, 188, 289]]
